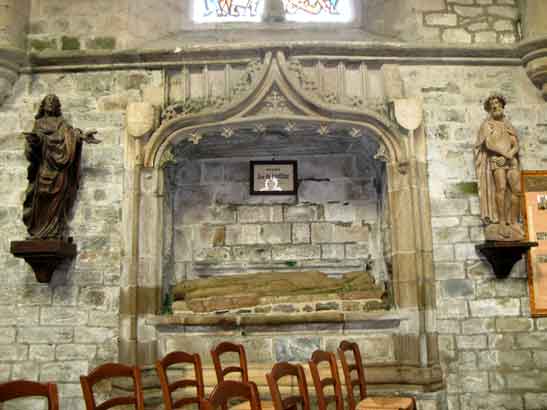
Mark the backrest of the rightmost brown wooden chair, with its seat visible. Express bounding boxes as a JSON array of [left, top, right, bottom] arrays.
[[338, 340, 367, 410]]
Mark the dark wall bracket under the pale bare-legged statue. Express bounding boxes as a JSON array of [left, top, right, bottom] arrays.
[[475, 241, 538, 278]]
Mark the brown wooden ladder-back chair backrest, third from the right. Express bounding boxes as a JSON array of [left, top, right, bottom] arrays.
[[266, 362, 310, 410]]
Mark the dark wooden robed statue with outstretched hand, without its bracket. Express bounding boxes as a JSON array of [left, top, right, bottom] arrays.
[[23, 94, 101, 239]]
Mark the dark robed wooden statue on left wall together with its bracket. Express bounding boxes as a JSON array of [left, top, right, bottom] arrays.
[[10, 94, 100, 282]]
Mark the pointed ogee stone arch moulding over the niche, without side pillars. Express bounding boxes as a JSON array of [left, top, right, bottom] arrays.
[[144, 51, 408, 170]]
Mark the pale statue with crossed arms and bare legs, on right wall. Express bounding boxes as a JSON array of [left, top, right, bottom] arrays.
[[474, 95, 524, 241]]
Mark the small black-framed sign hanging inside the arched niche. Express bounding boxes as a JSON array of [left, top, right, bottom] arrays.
[[250, 161, 297, 195]]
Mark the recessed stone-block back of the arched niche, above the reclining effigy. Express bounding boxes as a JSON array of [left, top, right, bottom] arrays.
[[162, 116, 391, 293]]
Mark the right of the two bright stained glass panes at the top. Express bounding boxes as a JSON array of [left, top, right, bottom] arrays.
[[283, 0, 352, 23]]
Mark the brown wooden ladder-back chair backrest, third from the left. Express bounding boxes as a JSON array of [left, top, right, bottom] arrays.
[[156, 352, 205, 410]]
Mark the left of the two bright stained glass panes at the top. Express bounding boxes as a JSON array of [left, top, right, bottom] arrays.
[[194, 0, 264, 23]]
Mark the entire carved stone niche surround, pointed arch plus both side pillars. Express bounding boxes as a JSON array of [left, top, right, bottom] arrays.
[[125, 51, 438, 384]]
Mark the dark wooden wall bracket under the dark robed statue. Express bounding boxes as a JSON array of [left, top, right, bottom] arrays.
[[10, 238, 76, 283]]
